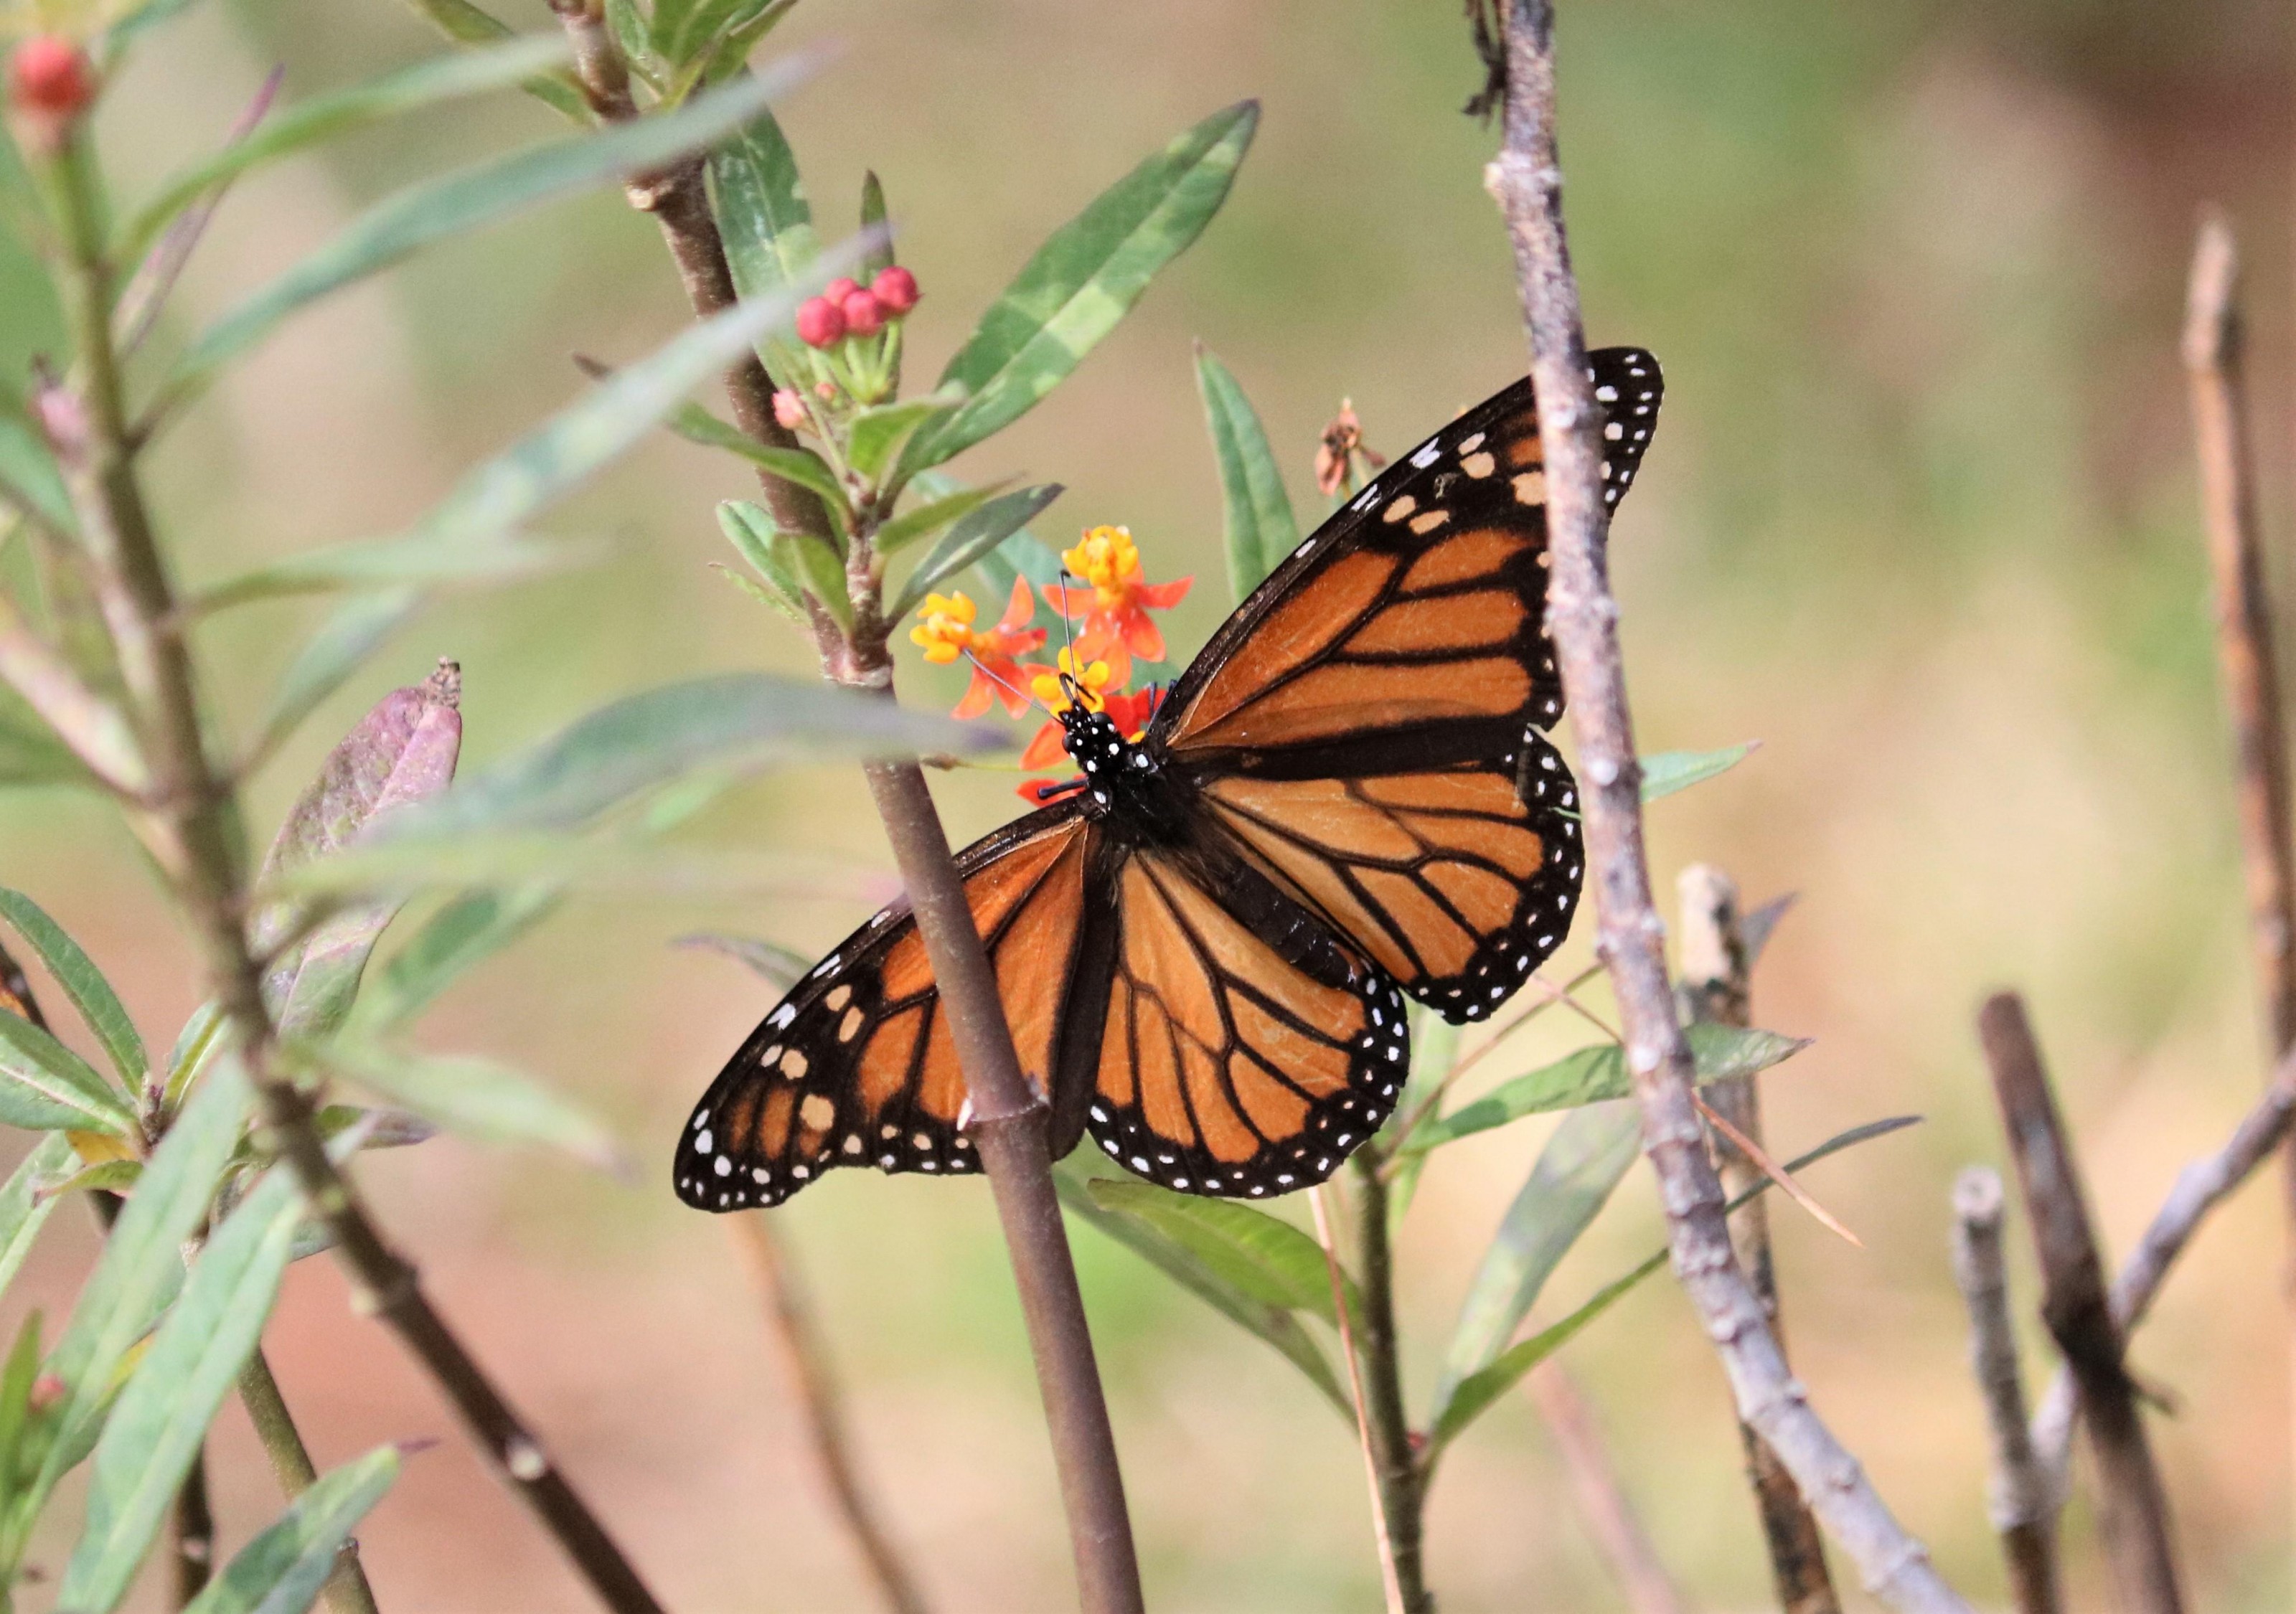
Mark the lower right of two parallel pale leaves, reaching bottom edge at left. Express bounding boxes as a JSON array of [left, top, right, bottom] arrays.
[[57, 1166, 301, 1614]]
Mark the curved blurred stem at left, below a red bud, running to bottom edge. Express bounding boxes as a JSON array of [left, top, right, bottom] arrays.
[[38, 117, 659, 1614]]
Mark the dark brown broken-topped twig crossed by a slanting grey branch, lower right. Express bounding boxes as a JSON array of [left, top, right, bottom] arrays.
[[1977, 992, 2183, 1614]]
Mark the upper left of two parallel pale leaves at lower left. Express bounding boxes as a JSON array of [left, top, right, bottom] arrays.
[[32, 1054, 253, 1511]]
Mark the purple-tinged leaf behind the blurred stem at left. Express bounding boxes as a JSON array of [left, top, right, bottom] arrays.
[[255, 661, 461, 1040]]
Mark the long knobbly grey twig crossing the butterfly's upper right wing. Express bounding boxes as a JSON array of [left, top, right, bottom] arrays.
[[1485, 0, 1967, 1614]]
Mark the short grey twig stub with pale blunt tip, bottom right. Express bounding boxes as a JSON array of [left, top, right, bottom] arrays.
[[1954, 1166, 2064, 1614]]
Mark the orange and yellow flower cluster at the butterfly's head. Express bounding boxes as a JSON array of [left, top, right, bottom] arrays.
[[909, 526, 1194, 806]]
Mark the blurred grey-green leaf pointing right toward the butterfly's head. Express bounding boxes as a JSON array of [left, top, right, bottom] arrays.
[[353, 673, 1001, 840]]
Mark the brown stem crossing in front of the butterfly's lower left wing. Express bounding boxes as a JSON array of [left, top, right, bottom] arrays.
[[540, 16, 1141, 1614]]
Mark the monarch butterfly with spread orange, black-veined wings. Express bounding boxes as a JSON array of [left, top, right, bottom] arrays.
[[675, 349, 1660, 1210]]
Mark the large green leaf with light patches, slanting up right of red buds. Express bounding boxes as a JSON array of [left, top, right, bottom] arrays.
[[905, 101, 1261, 471]]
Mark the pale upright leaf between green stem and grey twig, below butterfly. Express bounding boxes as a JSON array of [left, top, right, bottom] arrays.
[[1431, 1100, 1642, 1423]]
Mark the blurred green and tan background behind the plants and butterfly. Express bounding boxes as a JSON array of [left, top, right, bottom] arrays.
[[0, 0, 2296, 1610]]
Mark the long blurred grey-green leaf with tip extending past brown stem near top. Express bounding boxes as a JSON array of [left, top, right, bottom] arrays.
[[168, 65, 808, 395]]
